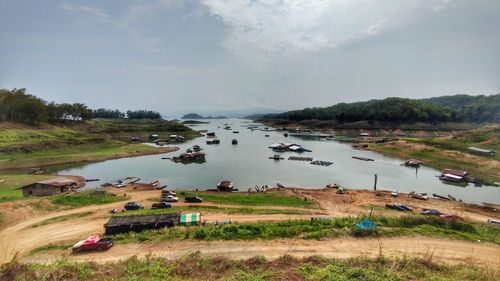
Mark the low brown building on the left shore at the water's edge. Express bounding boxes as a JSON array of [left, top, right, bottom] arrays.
[[21, 178, 82, 196]]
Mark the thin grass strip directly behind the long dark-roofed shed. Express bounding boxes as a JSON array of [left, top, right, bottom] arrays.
[[116, 206, 309, 216]]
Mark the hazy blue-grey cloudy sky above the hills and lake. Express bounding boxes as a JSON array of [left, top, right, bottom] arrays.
[[0, 0, 500, 115]]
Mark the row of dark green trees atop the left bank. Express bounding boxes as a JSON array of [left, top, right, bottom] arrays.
[[0, 89, 161, 124]]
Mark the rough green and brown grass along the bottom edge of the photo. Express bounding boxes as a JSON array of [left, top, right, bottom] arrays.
[[5, 250, 500, 281]]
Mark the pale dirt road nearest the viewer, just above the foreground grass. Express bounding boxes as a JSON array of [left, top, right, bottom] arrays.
[[22, 237, 500, 268]]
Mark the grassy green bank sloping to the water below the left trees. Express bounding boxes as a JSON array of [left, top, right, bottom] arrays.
[[0, 119, 200, 170]]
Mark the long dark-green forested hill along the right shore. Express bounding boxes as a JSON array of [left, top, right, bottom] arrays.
[[265, 95, 500, 123]]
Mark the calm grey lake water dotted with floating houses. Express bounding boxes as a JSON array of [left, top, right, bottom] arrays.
[[59, 119, 500, 203]]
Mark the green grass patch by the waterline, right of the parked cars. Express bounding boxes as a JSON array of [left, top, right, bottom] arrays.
[[179, 192, 317, 208]]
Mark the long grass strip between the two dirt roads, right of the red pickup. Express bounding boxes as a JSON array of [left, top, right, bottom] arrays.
[[109, 216, 500, 244]]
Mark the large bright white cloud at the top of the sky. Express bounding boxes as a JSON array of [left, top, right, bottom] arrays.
[[202, 0, 458, 59]]
